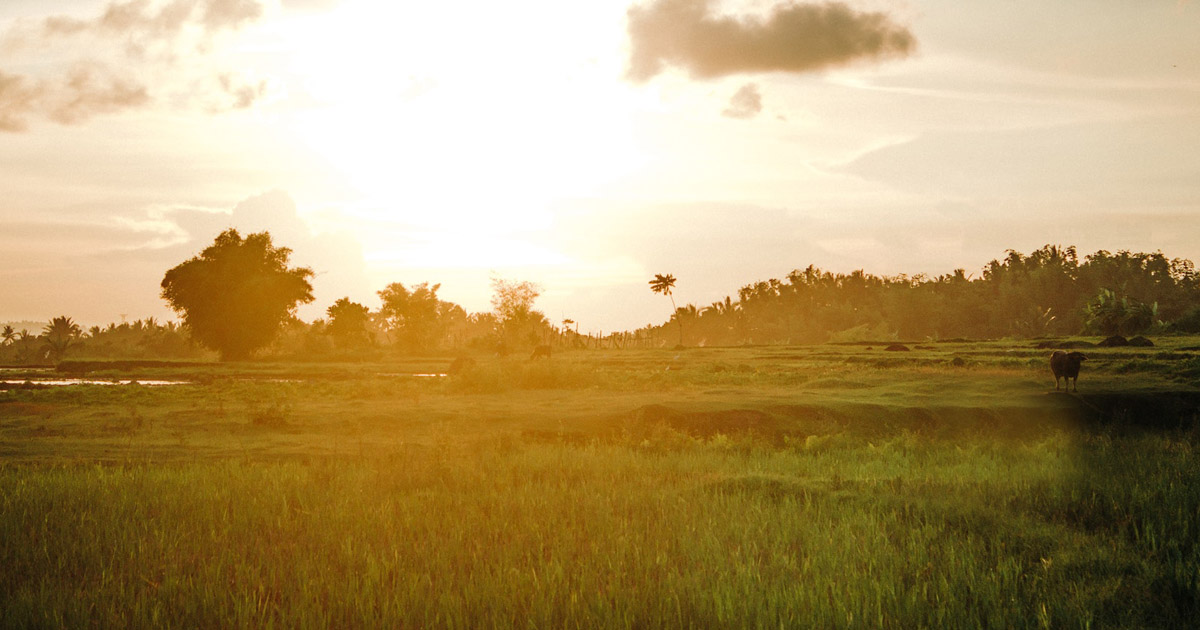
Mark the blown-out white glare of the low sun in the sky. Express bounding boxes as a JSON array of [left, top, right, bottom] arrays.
[[273, 1, 640, 266]]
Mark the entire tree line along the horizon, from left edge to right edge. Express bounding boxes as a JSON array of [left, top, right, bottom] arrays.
[[0, 235, 1200, 364]]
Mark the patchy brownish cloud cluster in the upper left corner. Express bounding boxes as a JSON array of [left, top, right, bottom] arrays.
[[0, 0, 268, 132]]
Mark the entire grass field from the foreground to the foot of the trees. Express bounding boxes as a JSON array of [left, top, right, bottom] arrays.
[[0, 337, 1200, 628]]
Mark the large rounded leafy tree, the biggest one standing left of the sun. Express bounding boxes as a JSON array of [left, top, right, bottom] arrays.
[[162, 229, 313, 361]]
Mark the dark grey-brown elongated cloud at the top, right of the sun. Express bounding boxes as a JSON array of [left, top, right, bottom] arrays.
[[625, 0, 917, 83]]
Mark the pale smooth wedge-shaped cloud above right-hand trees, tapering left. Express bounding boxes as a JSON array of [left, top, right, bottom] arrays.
[[833, 114, 1200, 204]]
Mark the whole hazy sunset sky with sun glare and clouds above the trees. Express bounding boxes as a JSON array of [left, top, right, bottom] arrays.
[[0, 0, 1200, 332]]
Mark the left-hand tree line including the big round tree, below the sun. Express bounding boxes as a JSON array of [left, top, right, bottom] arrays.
[[0, 229, 575, 365]]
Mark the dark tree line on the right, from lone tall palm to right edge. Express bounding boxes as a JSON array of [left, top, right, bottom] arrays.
[[652, 245, 1200, 344]]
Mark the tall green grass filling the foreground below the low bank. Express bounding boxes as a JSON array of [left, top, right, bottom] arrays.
[[0, 433, 1200, 628]]
